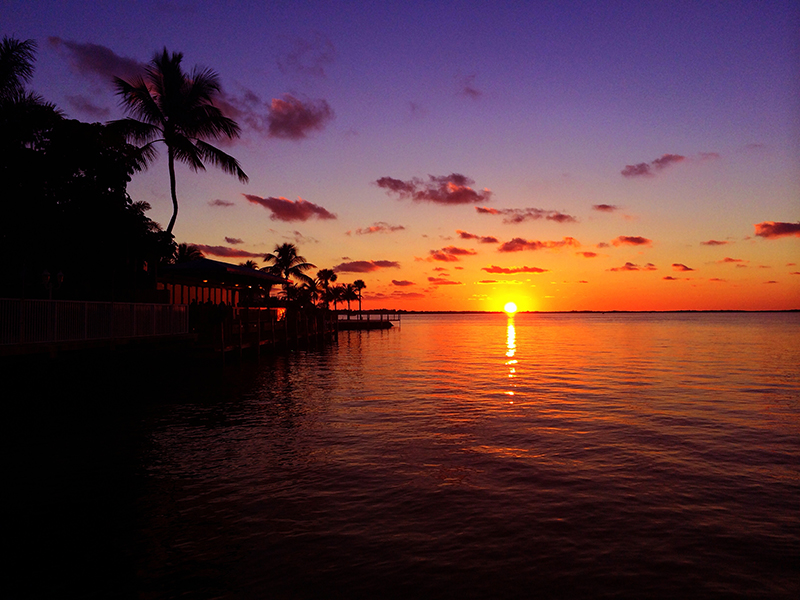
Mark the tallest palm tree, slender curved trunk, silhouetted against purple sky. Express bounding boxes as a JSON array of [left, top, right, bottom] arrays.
[[114, 48, 248, 235]]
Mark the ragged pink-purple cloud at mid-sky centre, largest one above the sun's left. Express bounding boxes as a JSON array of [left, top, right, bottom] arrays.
[[375, 173, 492, 204]]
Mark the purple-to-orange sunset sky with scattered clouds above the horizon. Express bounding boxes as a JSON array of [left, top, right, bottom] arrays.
[[6, 0, 800, 310]]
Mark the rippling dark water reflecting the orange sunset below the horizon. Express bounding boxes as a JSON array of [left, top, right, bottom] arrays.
[[4, 313, 800, 599]]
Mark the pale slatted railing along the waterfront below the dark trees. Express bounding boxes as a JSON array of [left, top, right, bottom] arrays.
[[0, 298, 189, 345]]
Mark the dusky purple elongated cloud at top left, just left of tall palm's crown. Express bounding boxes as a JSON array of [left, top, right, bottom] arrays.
[[47, 36, 145, 88]]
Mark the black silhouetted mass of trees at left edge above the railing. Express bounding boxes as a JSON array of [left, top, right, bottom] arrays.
[[0, 38, 174, 300]]
